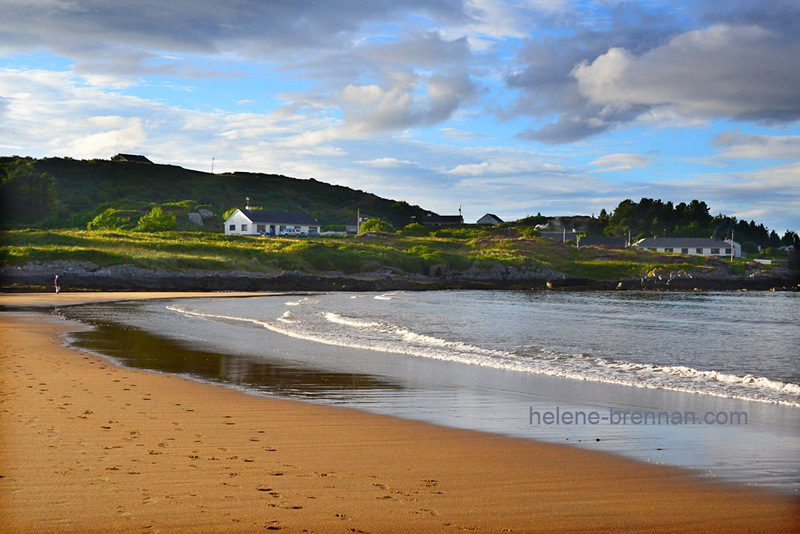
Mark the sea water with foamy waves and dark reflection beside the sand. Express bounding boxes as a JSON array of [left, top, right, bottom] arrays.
[[61, 291, 800, 493]]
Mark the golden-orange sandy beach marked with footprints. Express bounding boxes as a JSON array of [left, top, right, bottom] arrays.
[[0, 293, 800, 532]]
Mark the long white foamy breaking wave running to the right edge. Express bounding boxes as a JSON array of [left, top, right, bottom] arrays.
[[168, 306, 800, 407]]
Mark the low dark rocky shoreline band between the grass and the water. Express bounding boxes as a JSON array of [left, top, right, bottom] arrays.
[[0, 261, 800, 291]]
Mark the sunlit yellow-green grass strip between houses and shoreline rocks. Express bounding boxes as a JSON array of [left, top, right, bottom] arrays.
[[0, 230, 719, 279]]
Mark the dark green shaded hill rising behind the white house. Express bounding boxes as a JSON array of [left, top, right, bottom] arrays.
[[0, 157, 430, 231]]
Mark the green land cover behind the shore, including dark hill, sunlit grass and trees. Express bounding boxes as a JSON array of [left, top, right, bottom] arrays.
[[0, 157, 800, 280]]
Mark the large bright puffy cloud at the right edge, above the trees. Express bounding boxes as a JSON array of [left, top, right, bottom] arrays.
[[572, 25, 800, 121]]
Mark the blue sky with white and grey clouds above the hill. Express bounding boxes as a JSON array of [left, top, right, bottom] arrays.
[[0, 0, 800, 234]]
